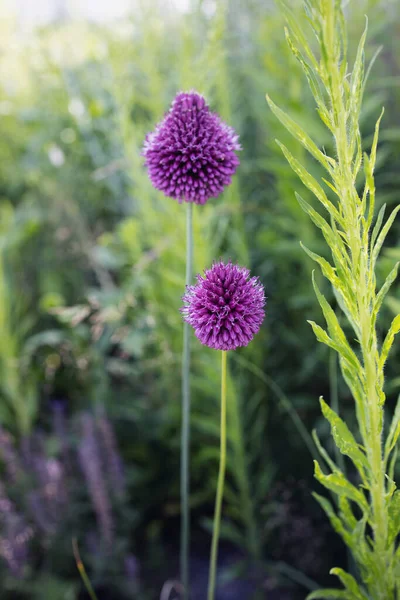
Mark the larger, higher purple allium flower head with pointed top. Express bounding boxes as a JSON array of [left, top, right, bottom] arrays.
[[143, 92, 241, 204]]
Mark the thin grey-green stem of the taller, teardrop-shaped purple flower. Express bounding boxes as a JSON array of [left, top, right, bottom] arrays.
[[180, 202, 193, 600]]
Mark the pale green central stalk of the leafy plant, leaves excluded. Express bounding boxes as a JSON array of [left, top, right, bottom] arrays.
[[327, 3, 393, 600]]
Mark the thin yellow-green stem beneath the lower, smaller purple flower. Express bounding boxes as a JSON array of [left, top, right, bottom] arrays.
[[207, 351, 227, 600]]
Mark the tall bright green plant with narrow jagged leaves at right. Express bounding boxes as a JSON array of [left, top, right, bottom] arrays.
[[268, 0, 400, 600]]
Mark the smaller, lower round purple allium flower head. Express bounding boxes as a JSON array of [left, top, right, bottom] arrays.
[[181, 262, 265, 350]]
